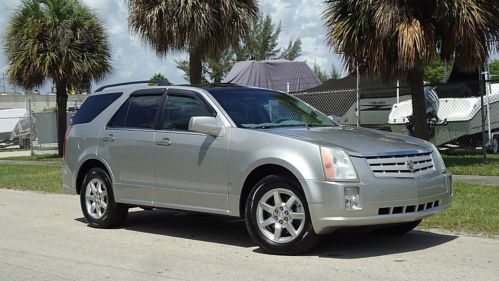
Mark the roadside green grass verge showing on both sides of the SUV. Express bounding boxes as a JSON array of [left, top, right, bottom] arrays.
[[0, 164, 499, 235]]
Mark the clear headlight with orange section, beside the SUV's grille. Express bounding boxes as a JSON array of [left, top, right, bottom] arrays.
[[321, 147, 358, 181]]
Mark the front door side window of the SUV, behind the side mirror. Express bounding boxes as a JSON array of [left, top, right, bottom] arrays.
[[163, 95, 213, 131]]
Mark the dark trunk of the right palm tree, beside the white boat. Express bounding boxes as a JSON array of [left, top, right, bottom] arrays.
[[407, 68, 430, 140]]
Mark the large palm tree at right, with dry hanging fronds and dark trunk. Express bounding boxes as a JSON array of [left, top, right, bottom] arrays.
[[323, 0, 499, 139]]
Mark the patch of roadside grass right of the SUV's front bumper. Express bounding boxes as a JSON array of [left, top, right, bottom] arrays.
[[420, 179, 499, 235]]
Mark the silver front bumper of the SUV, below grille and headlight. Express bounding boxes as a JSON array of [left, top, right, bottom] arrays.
[[301, 172, 452, 234]]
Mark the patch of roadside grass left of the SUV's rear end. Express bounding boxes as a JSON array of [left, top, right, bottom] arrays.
[[0, 164, 68, 193]]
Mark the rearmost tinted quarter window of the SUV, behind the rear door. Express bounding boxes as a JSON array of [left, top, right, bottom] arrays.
[[73, 93, 123, 125]]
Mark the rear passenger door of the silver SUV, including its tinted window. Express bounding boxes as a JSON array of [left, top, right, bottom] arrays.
[[99, 89, 165, 205]]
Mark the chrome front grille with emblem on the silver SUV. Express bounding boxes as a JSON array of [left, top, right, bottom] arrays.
[[366, 153, 435, 178]]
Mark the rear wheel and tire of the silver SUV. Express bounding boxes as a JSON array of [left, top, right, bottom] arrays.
[[80, 168, 128, 228]]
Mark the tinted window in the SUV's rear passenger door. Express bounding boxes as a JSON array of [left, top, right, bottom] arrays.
[[109, 95, 161, 129]]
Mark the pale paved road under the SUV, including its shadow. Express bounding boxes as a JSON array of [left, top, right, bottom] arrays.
[[0, 189, 499, 281]]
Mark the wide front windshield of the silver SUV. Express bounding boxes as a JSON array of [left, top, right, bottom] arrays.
[[208, 89, 336, 128]]
